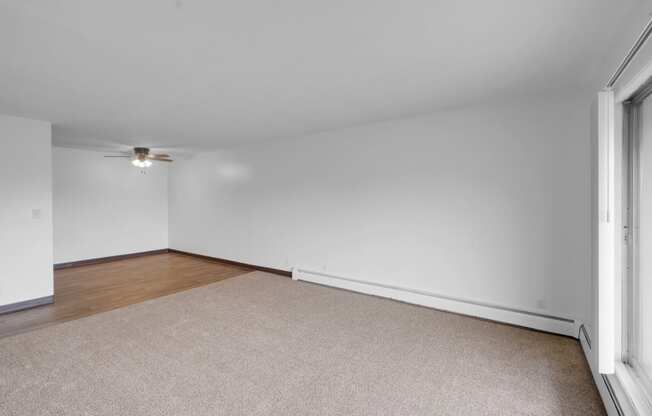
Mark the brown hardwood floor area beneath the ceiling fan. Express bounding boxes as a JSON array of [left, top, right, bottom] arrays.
[[0, 253, 253, 337]]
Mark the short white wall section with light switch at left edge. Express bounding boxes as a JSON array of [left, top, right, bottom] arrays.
[[0, 115, 53, 306]]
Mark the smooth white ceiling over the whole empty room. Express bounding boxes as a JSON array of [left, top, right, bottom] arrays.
[[0, 0, 642, 148]]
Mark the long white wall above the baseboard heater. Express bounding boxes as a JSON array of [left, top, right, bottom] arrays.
[[170, 98, 591, 319]]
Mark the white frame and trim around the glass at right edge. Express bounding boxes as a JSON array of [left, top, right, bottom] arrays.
[[598, 75, 652, 415]]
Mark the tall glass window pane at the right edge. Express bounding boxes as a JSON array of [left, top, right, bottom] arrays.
[[621, 92, 652, 410]]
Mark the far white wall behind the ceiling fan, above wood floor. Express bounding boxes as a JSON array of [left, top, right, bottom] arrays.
[[53, 147, 168, 263]]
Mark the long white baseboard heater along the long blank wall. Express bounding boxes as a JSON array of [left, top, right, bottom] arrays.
[[292, 267, 578, 338]]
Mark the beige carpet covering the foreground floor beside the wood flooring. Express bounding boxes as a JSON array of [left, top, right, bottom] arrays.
[[0, 272, 604, 416]]
